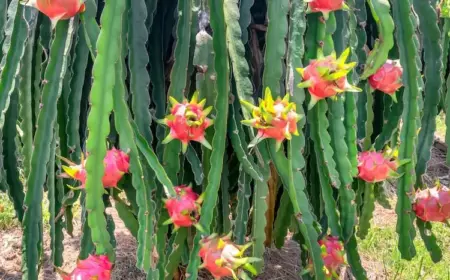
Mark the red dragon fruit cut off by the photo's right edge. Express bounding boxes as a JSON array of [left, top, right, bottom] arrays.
[[413, 184, 450, 222]]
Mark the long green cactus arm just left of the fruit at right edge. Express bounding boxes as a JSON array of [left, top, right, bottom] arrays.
[[392, 0, 421, 259]]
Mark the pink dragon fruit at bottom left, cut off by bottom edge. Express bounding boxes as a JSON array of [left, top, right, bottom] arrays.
[[57, 255, 113, 280]]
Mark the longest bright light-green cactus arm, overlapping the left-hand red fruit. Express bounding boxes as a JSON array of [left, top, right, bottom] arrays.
[[86, 0, 126, 260]]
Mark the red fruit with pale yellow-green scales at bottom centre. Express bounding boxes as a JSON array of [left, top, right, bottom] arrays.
[[199, 234, 259, 279]]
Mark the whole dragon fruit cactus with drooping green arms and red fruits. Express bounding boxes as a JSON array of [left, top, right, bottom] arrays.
[[0, 0, 450, 280]]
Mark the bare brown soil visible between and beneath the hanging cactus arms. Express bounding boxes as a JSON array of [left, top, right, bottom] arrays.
[[0, 141, 449, 280]]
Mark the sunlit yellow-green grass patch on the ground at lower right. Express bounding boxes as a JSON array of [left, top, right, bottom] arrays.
[[359, 205, 450, 280]]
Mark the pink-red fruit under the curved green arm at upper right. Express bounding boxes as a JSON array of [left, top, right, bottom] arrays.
[[369, 59, 403, 102]]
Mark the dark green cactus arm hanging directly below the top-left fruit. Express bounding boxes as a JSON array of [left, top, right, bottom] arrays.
[[22, 18, 74, 279]]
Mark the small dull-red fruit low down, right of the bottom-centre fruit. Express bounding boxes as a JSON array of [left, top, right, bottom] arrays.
[[319, 236, 345, 279]]
